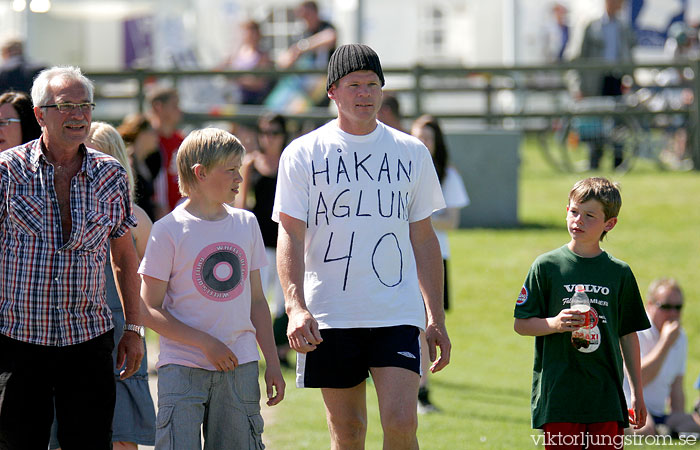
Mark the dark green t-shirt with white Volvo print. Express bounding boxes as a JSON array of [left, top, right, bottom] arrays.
[[514, 245, 650, 428]]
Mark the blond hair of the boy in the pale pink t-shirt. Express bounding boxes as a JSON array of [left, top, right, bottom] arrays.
[[177, 128, 245, 197]]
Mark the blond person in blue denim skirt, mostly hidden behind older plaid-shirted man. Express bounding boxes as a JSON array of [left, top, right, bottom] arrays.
[[49, 122, 156, 450]]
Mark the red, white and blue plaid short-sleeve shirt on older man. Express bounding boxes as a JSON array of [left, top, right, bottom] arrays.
[[0, 139, 136, 346]]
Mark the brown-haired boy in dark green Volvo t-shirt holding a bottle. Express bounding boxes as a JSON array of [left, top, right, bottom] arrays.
[[514, 178, 650, 449]]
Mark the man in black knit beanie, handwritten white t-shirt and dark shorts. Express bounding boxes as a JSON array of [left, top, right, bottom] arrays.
[[273, 44, 450, 449]]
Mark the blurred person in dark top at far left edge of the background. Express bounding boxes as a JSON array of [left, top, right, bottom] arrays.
[[0, 38, 45, 94]]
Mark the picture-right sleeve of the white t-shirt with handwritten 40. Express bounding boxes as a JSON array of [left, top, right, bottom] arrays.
[[408, 146, 445, 222]]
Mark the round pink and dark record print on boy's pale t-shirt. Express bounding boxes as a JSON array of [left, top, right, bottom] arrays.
[[192, 242, 248, 302]]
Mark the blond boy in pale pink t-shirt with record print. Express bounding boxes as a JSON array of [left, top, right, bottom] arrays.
[[139, 128, 285, 449]]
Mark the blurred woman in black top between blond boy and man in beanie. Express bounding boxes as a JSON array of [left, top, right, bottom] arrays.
[[236, 113, 290, 367]]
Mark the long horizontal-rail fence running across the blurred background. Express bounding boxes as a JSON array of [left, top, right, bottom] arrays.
[[87, 60, 700, 169]]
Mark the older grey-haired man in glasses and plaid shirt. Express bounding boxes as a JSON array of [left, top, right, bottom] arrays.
[[0, 67, 143, 450]]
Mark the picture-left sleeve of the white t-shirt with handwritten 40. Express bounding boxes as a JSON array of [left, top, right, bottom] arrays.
[[272, 142, 310, 222]]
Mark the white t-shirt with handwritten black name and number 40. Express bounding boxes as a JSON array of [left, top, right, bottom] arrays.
[[272, 120, 445, 328]]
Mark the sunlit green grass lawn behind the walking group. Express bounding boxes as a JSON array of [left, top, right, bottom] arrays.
[[263, 134, 700, 450]]
